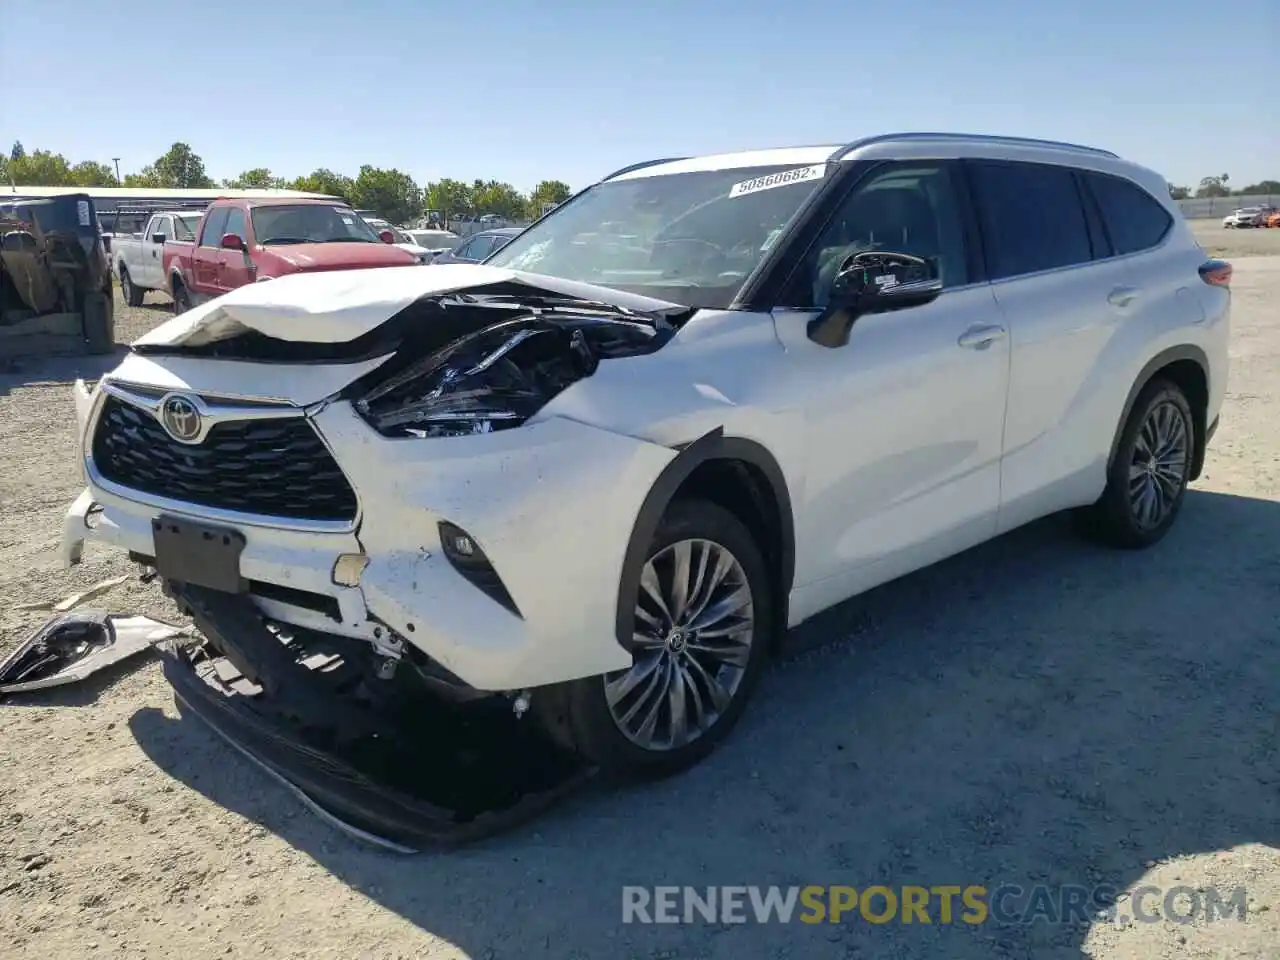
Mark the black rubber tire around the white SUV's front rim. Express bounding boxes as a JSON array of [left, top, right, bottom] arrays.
[[567, 500, 774, 777]]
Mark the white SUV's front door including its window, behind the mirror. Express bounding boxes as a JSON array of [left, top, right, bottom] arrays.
[[776, 160, 1009, 616]]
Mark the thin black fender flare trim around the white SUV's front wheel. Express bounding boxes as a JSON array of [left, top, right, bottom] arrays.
[[616, 426, 796, 650]]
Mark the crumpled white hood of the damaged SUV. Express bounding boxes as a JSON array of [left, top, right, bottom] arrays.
[[133, 263, 689, 347]]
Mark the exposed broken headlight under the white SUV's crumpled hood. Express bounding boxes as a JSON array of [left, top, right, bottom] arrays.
[[356, 316, 599, 436]]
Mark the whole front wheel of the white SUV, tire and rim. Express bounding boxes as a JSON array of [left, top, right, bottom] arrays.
[[534, 500, 774, 777]]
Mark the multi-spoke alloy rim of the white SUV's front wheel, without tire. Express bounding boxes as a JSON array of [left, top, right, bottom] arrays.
[[604, 539, 755, 751]]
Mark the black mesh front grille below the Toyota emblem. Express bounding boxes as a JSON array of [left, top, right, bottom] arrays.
[[93, 396, 356, 521]]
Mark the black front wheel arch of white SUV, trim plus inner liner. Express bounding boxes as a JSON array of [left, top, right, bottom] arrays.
[[617, 426, 795, 649]]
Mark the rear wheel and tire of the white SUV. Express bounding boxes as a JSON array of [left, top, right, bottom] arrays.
[[1076, 380, 1197, 550]]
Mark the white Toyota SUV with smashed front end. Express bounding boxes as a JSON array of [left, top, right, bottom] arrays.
[[64, 133, 1231, 788]]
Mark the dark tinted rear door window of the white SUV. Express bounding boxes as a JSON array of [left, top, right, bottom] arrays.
[[969, 160, 1093, 280]]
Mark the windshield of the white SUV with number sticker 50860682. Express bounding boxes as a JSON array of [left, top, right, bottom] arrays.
[[485, 164, 827, 308]]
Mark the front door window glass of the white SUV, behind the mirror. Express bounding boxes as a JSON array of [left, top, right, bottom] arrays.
[[787, 163, 969, 308]]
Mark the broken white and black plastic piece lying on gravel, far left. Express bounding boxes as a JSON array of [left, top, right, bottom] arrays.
[[0, 611, 189, 694]]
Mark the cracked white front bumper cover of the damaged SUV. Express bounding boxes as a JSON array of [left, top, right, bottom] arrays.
[[63, 384, 676, 691]]
